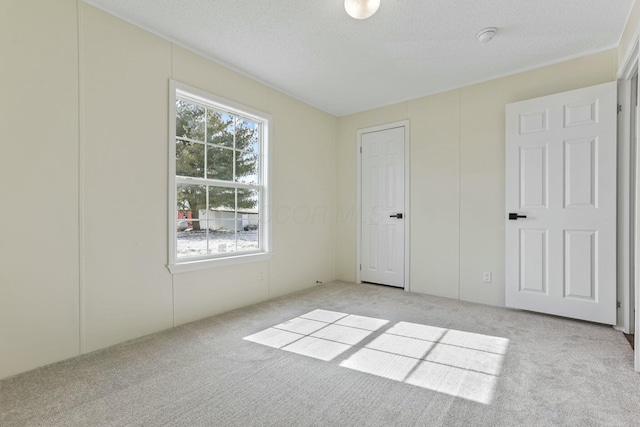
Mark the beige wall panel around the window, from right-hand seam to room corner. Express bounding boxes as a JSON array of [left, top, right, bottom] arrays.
[[170, 46, 336, 324]]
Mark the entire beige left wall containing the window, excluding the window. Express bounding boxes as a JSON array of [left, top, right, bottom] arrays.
[[0, 0, 336, 378]]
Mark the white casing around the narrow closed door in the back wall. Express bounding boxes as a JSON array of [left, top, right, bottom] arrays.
[[356, 120, 411, 291]]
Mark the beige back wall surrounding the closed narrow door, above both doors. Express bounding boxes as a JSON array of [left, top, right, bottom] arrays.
[[336, 49, 617, 305]]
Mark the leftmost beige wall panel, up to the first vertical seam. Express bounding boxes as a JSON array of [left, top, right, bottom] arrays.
[[0, 0, 79, 378]]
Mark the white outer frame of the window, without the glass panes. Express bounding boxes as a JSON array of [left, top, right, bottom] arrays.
[[167, 80, 271, 274]]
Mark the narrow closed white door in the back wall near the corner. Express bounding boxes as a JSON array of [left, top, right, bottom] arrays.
[[360, 127, 406, 287]]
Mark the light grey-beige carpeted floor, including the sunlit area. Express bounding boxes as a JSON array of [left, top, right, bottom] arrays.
[[0, 283, 640, 427]]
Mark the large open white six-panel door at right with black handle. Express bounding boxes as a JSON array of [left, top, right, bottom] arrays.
[[505, 82, 617, 324]]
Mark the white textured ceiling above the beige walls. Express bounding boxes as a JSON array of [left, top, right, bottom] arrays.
[[85, 0, 634, 116]]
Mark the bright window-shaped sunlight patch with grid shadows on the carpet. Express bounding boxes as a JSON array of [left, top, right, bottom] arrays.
[[244, 309, 509, 405]]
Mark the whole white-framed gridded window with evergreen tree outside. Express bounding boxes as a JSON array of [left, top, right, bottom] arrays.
[[169, 82, 269, 272]]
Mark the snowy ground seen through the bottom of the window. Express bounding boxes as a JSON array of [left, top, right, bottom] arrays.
[[177, 230, 259, 258]]
